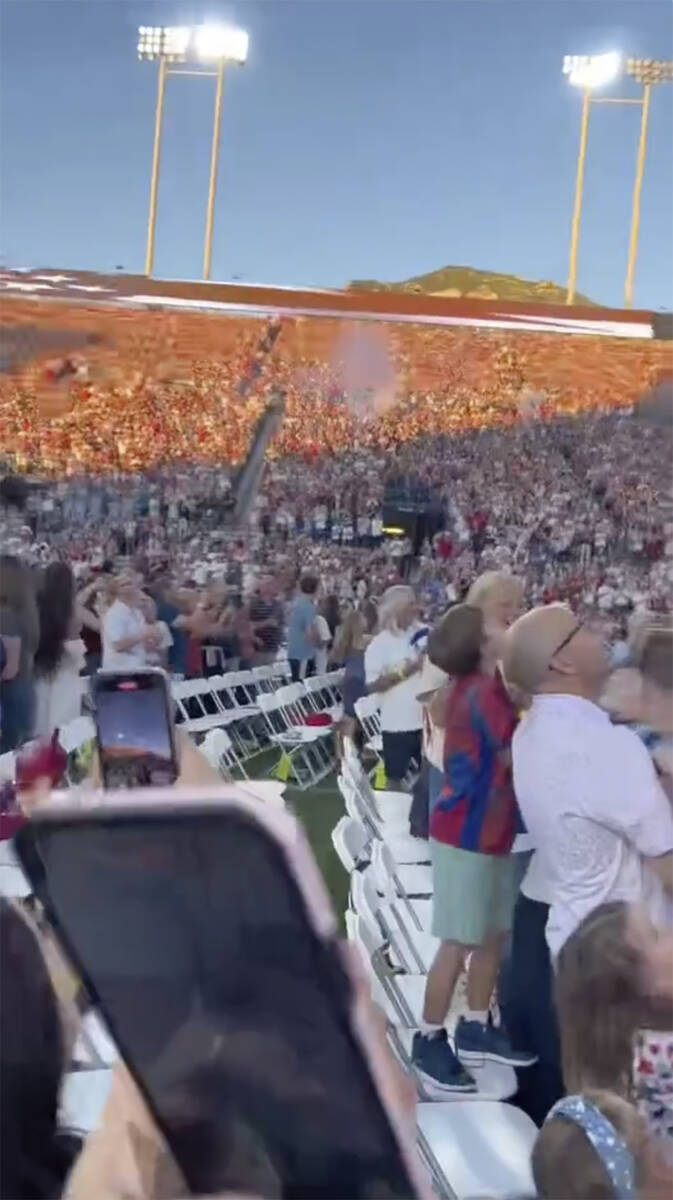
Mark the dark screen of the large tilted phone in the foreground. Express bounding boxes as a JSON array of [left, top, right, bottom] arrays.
[[17, 809, 414, 1200]]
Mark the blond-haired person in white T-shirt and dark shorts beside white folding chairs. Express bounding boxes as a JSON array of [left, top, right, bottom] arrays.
[[365, 586, 423, 790]]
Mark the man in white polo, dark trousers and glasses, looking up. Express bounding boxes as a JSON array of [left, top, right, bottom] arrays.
[[500, 605, 673, 1124]]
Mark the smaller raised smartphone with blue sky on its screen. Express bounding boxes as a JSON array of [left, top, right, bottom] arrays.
[[92, 667, 179, 790]]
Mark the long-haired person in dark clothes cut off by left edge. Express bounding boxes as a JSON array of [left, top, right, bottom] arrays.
[[0, 554, 40, 754]]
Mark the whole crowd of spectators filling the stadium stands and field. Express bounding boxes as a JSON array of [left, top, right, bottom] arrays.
[[0, 312, 673, 1198]]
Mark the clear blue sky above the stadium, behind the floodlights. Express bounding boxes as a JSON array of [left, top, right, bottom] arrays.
[[0, 0, 673, 308]]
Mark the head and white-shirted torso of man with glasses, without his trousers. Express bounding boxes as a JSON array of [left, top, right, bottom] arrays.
[[505, 604, 673, 958]]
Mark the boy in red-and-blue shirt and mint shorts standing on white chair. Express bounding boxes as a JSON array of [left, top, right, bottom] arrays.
[[413, 604, 535, 1092]]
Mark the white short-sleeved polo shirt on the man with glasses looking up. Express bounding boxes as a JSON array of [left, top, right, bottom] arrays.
[[512, 695, 673, 956]]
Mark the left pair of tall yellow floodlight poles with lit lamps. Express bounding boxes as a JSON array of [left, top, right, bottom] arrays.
[[138, 25, 248, 280]]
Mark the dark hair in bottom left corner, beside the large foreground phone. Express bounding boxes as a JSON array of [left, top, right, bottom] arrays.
[[0, 899, 76, 1200]]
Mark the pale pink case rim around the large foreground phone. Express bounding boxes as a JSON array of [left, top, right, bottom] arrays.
[[32, 781, 433, 1200]]
